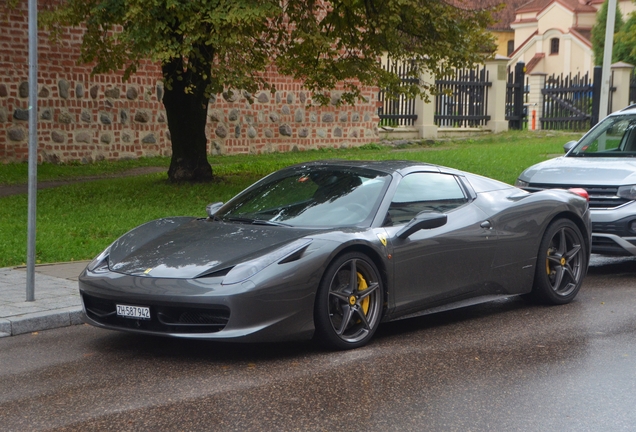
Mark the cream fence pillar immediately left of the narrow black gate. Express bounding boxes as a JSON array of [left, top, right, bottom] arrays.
[[485, 55, 509, 133]]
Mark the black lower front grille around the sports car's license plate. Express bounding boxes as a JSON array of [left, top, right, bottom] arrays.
[[82, 293, 230, 334]]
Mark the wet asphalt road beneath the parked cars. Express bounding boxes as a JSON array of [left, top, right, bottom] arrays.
[[0, 255, 636, 431]]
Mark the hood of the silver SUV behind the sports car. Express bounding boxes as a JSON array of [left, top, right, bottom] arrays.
[[519, 156, 636, 186]]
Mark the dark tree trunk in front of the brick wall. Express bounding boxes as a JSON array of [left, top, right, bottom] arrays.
[[162, 55, 212, 182]]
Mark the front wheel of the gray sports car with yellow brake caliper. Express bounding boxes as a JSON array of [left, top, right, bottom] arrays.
[[314, 252, 384, 350]]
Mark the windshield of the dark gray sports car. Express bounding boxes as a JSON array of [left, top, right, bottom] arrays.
[[215, 167, 391, 227]]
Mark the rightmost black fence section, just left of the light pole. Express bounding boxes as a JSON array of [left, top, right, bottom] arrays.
[[539, 73, 593, 130]]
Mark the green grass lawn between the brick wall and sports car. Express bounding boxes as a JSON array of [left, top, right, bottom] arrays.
[[0, 132, 581, 267]]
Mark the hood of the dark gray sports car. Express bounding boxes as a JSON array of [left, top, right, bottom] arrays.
[[109, 218, 316, 279]]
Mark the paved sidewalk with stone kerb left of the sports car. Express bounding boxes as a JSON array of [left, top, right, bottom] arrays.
[[0, 261, 89, 337]]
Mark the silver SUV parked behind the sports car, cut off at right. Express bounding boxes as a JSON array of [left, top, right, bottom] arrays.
[[516, 105, 636, 256]]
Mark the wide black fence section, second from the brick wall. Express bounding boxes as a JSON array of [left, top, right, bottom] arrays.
[[435, 67, 492, 127]]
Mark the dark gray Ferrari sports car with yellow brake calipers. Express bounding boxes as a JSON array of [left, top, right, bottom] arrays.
[[79, 161, 590, 349]]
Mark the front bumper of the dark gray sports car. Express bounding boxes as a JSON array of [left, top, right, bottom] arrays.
[[79, 271, 315, 342]]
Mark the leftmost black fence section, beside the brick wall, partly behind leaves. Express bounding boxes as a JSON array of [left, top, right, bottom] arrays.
[[378, 59, 420, 126]]
